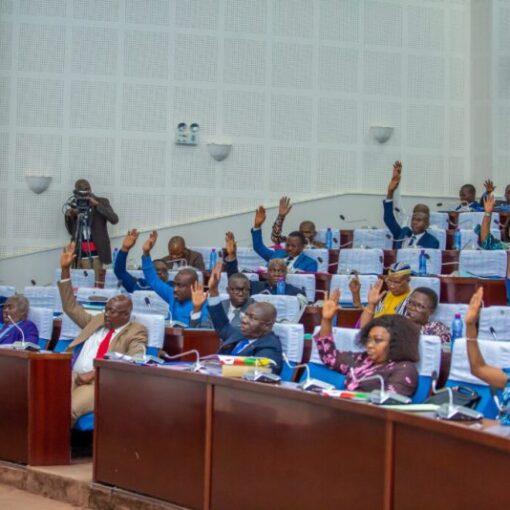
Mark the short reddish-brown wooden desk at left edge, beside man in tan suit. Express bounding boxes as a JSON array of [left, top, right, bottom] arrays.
[[0, 349, 71, 466]]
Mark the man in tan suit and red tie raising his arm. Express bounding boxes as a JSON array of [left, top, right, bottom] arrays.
[[58, 243, 147, 421]]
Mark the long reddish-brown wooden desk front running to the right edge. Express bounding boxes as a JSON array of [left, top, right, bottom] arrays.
[[94, 361, 510, 510]]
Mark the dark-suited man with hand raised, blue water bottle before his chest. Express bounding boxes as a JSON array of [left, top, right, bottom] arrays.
[[225, 232, 308, 298]]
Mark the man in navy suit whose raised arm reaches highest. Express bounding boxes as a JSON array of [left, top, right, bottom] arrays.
[[383, 161, 439, 250]]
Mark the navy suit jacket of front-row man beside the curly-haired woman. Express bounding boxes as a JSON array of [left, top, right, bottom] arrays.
[[209, 303, 283, 374]]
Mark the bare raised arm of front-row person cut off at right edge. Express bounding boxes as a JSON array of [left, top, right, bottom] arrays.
[[465, 287, 508, 388]]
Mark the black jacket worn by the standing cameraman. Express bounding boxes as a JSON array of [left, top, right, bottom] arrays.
[[65, 196, 119, 264]]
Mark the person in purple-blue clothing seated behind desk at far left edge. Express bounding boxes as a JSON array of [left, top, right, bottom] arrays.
[[0, 294, 39, 345]]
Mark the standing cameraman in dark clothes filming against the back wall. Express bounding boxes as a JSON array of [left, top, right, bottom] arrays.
[[65, 179, 119, 281]]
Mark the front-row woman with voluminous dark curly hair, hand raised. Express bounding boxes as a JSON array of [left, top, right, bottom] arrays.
[[314, 289, 420, 397]]
